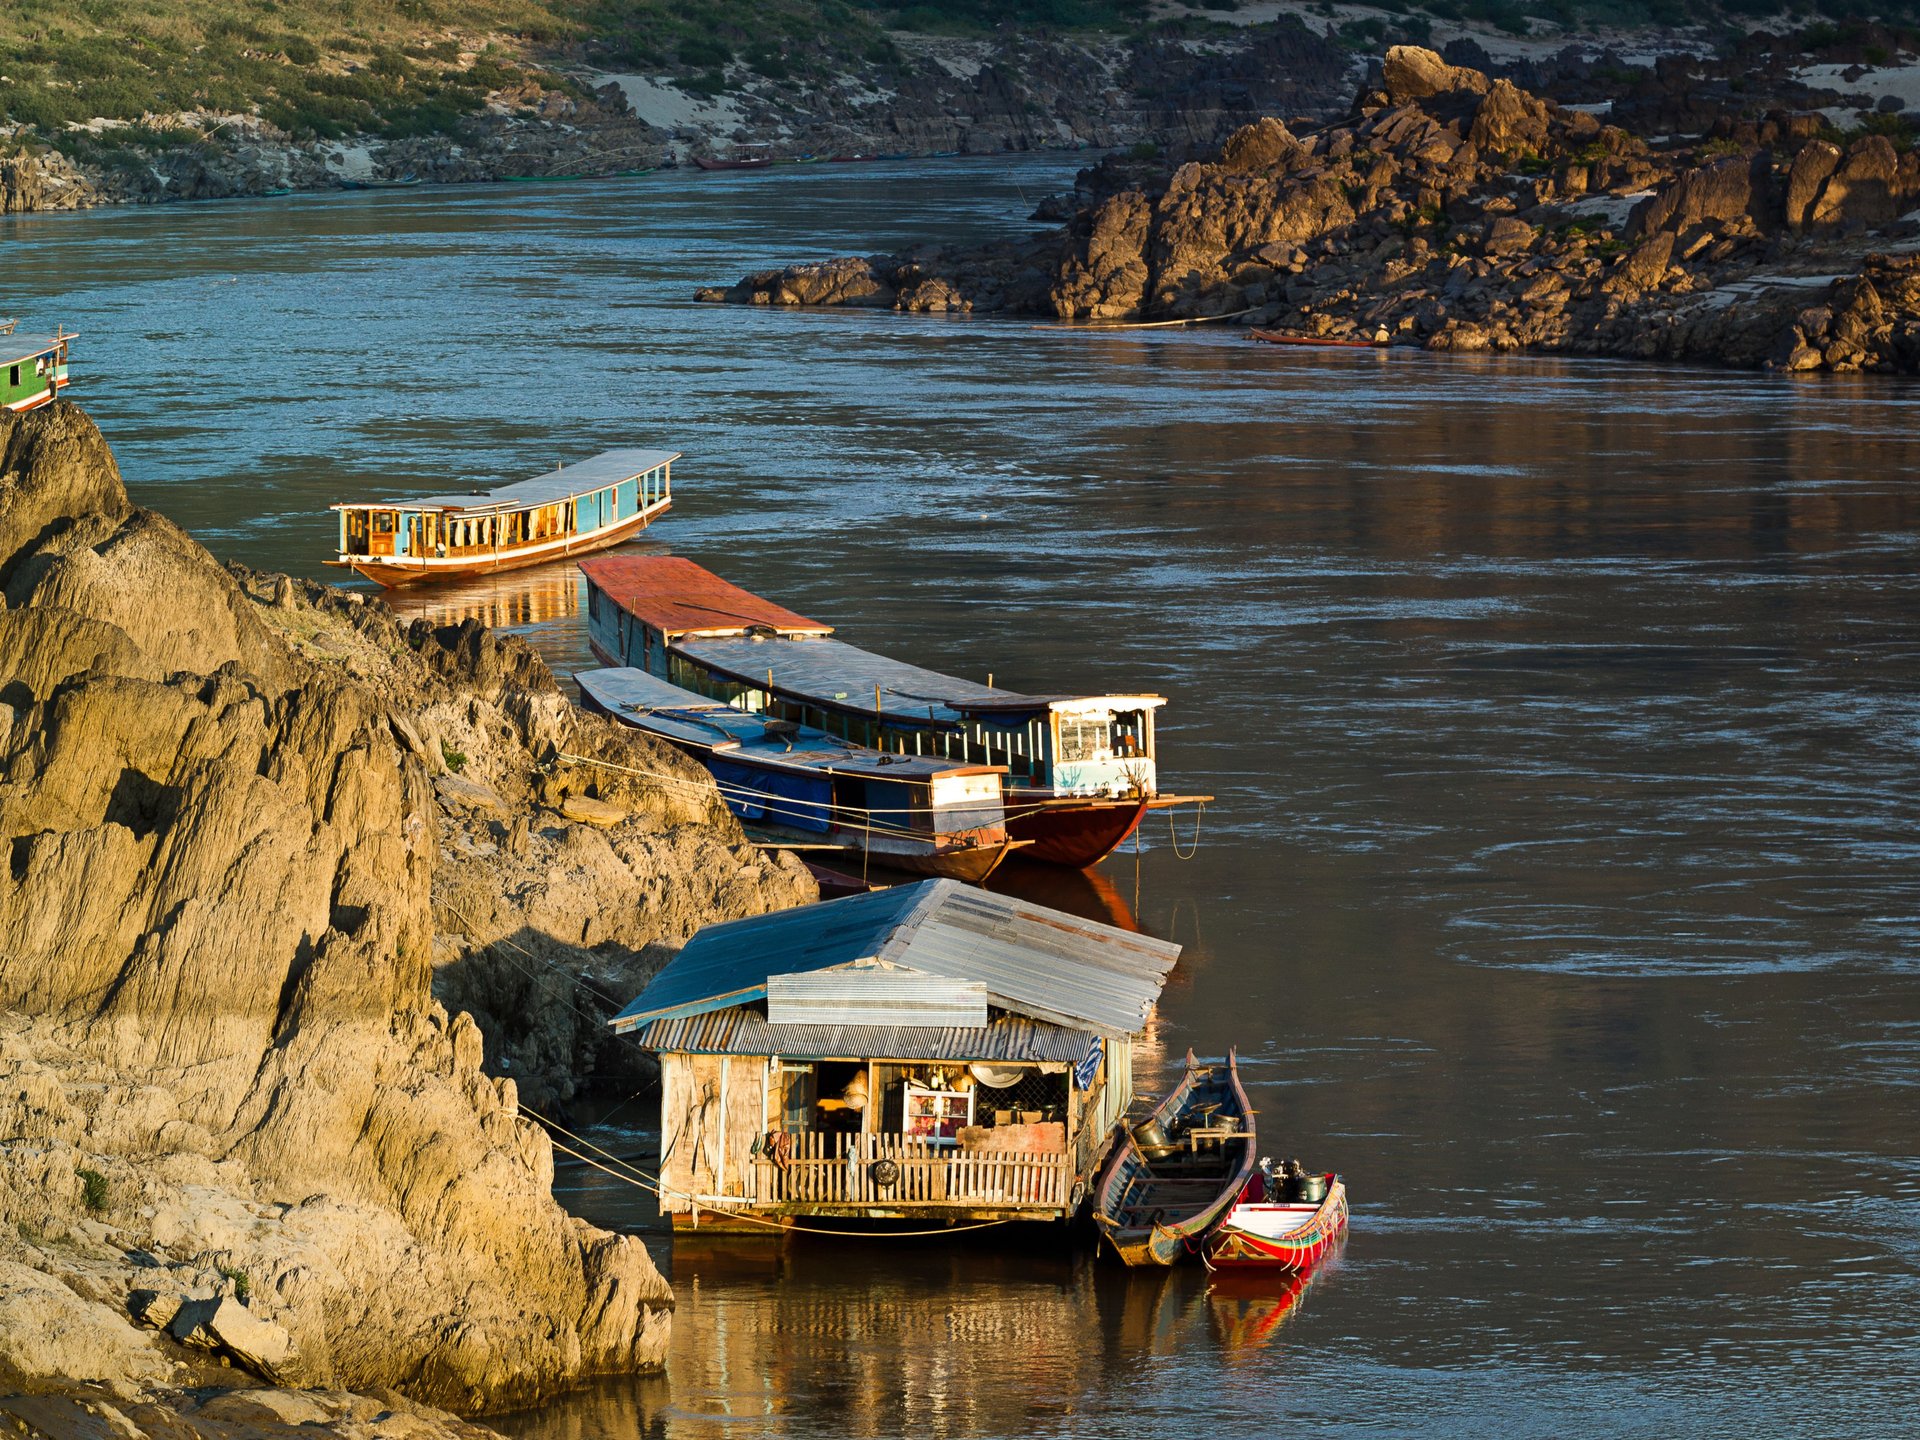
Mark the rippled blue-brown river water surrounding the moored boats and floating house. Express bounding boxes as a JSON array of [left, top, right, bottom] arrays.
[[0, 156, 1920, 1440]]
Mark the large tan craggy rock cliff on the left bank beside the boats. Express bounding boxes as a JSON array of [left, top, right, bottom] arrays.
[[0, 403, 810, 1434]]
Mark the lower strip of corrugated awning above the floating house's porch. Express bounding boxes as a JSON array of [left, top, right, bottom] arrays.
[[634, 1006, 1092, 1066]]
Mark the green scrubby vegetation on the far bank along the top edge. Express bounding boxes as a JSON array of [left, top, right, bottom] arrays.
[[11, 0, 1920, 156]]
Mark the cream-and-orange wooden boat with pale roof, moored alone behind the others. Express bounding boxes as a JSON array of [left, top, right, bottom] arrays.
[[326, 449, 680, 588]]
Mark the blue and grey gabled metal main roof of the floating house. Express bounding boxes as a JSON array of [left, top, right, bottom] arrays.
[[612, 879, 1181, 1035]]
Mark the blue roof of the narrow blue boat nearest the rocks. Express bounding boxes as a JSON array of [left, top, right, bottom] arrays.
[[574, 666, 1006, 783]]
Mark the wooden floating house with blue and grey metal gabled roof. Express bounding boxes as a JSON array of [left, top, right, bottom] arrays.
[[612, 879, 1179, 1229]]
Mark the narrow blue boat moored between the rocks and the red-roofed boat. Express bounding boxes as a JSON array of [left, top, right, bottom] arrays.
[[574, 666, 1018, 881]]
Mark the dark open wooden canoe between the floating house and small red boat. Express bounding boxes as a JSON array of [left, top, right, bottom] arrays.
[[1092, 1050, 1254, 1265]]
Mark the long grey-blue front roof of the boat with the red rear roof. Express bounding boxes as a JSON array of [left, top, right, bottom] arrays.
[[674, 636, 1165, 724]]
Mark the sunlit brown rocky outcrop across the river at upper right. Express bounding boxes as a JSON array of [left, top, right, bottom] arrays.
[[701, 46, 1920, 371]]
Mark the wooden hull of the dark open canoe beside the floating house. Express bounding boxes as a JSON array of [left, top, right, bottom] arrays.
[[1092, 1050, 1256, 1265]]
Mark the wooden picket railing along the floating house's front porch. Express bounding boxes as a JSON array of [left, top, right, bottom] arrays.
[[753, 1133, 1073, 1210]]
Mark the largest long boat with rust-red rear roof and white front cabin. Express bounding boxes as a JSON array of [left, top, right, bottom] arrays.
[[580, 555, 1210, 870]]
